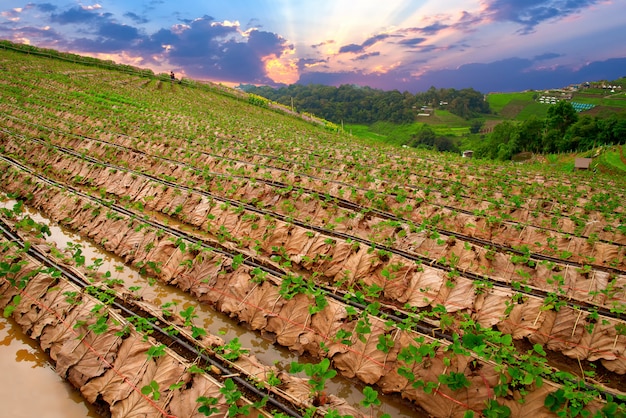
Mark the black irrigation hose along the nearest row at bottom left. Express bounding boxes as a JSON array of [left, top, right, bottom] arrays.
[[0, 219, 302, 418]]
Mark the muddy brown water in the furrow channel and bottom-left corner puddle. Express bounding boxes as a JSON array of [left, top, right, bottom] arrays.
[[0, 201, 427, 417]]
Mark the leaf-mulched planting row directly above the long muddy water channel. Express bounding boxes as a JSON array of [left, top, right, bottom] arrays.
[[4, 155, 620, 415]]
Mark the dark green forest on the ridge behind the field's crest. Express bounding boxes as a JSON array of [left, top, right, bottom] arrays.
[[239, 84, 490, 124]]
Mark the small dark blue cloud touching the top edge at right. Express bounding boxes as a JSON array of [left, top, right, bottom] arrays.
[[485, 0, 600, 34]]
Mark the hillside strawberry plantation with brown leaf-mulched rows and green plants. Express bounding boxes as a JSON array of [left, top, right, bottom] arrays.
[[0, 41, 626, 417]]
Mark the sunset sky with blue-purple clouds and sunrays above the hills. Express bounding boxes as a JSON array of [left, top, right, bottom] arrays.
[[0, 0, 626, 93]]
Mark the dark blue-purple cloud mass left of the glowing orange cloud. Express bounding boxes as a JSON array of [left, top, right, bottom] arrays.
[[7, 1, 288, 84]]
